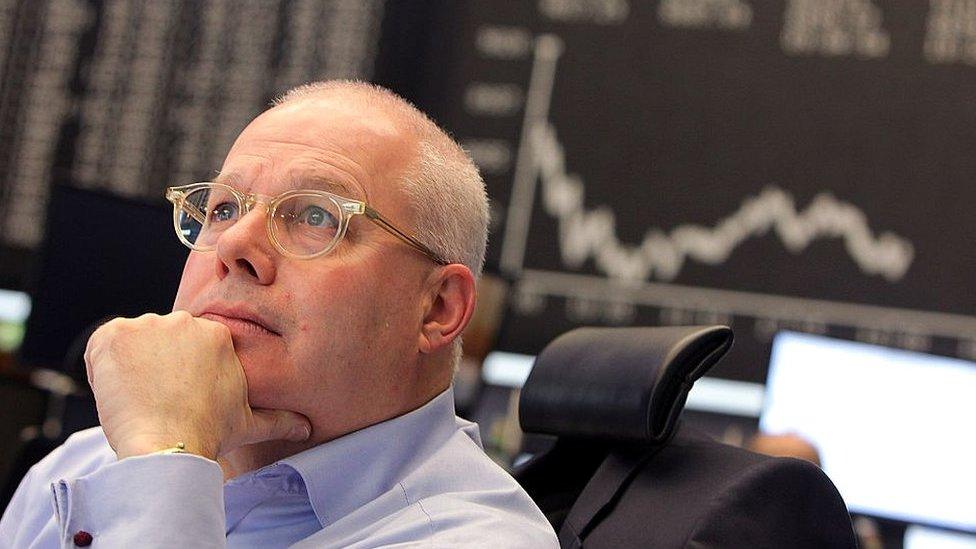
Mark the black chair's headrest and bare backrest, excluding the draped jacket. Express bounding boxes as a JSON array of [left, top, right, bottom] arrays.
[[514, 326, 732, 530]]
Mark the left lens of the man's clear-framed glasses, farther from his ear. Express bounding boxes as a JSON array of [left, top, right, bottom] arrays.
[[177, 186, 241, 248]]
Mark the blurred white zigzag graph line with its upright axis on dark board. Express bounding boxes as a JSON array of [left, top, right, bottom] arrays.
[[501, 35, 915, 283]]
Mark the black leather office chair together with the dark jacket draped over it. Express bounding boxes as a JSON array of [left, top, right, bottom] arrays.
[[515, 326, 856, 547]]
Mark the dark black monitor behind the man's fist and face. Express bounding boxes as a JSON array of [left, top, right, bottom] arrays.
[[19, 185, 188, 369]]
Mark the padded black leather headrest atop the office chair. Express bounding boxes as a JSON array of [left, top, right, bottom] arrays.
[[519, 326, 732, 443]]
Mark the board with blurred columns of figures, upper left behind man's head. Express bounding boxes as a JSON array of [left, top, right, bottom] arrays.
[[0, 0, 384, 252]]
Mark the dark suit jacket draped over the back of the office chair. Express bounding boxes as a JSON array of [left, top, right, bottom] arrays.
[[560, 430, 856, 548]]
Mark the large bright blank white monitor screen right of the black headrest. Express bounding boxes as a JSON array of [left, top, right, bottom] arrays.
[[760, 332, 976, 532]]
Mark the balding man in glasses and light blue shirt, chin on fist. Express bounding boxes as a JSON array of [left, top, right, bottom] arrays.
[[0, 82, 556, 547]]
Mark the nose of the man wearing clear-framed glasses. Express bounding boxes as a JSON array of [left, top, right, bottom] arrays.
[[217, 204, 279, 284]]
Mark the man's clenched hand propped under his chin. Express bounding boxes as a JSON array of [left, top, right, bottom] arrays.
[[85, 311, 311, 459]]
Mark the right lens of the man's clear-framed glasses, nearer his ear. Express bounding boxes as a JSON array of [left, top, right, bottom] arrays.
[[271, 194, 342, 256]]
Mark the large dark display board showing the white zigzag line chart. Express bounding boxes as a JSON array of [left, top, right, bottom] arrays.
[[424, 0, 976, 381]]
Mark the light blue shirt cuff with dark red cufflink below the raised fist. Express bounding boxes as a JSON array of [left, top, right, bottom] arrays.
[[51, 454, 225, 548]]
